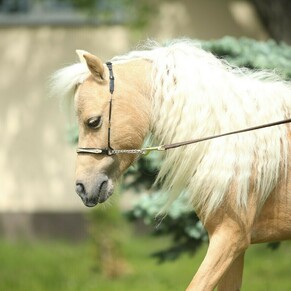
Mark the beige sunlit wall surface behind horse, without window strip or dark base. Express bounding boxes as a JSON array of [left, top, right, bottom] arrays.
[[0, 0, 266, 212]]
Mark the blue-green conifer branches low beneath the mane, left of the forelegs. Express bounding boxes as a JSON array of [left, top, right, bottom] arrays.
[[127, 192, 207, 262]]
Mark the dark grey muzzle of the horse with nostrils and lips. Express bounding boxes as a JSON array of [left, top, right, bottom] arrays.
[[76, 174, 113, 207]]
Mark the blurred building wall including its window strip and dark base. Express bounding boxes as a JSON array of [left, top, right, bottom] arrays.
[[0, 0, 276, 238]]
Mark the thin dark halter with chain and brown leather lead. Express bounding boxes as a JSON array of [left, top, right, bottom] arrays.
[[77, 62, 291, 156]]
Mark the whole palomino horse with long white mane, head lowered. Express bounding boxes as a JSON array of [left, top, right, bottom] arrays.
[[53, 40, 291, 291]]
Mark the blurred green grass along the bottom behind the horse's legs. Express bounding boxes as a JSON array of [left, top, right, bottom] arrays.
[[0, 235, 291, 291]]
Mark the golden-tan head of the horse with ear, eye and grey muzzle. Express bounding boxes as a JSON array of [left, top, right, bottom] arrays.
[[75, 51, 150, 207]]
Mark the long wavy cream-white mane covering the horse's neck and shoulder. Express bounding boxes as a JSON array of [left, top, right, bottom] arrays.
[[113, 40, 291, 216]]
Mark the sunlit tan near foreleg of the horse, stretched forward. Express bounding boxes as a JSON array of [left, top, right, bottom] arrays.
[[187, 228, 249, 291]]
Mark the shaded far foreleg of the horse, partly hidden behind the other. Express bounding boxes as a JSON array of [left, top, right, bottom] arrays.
[[217, 252, 244, 291]]
